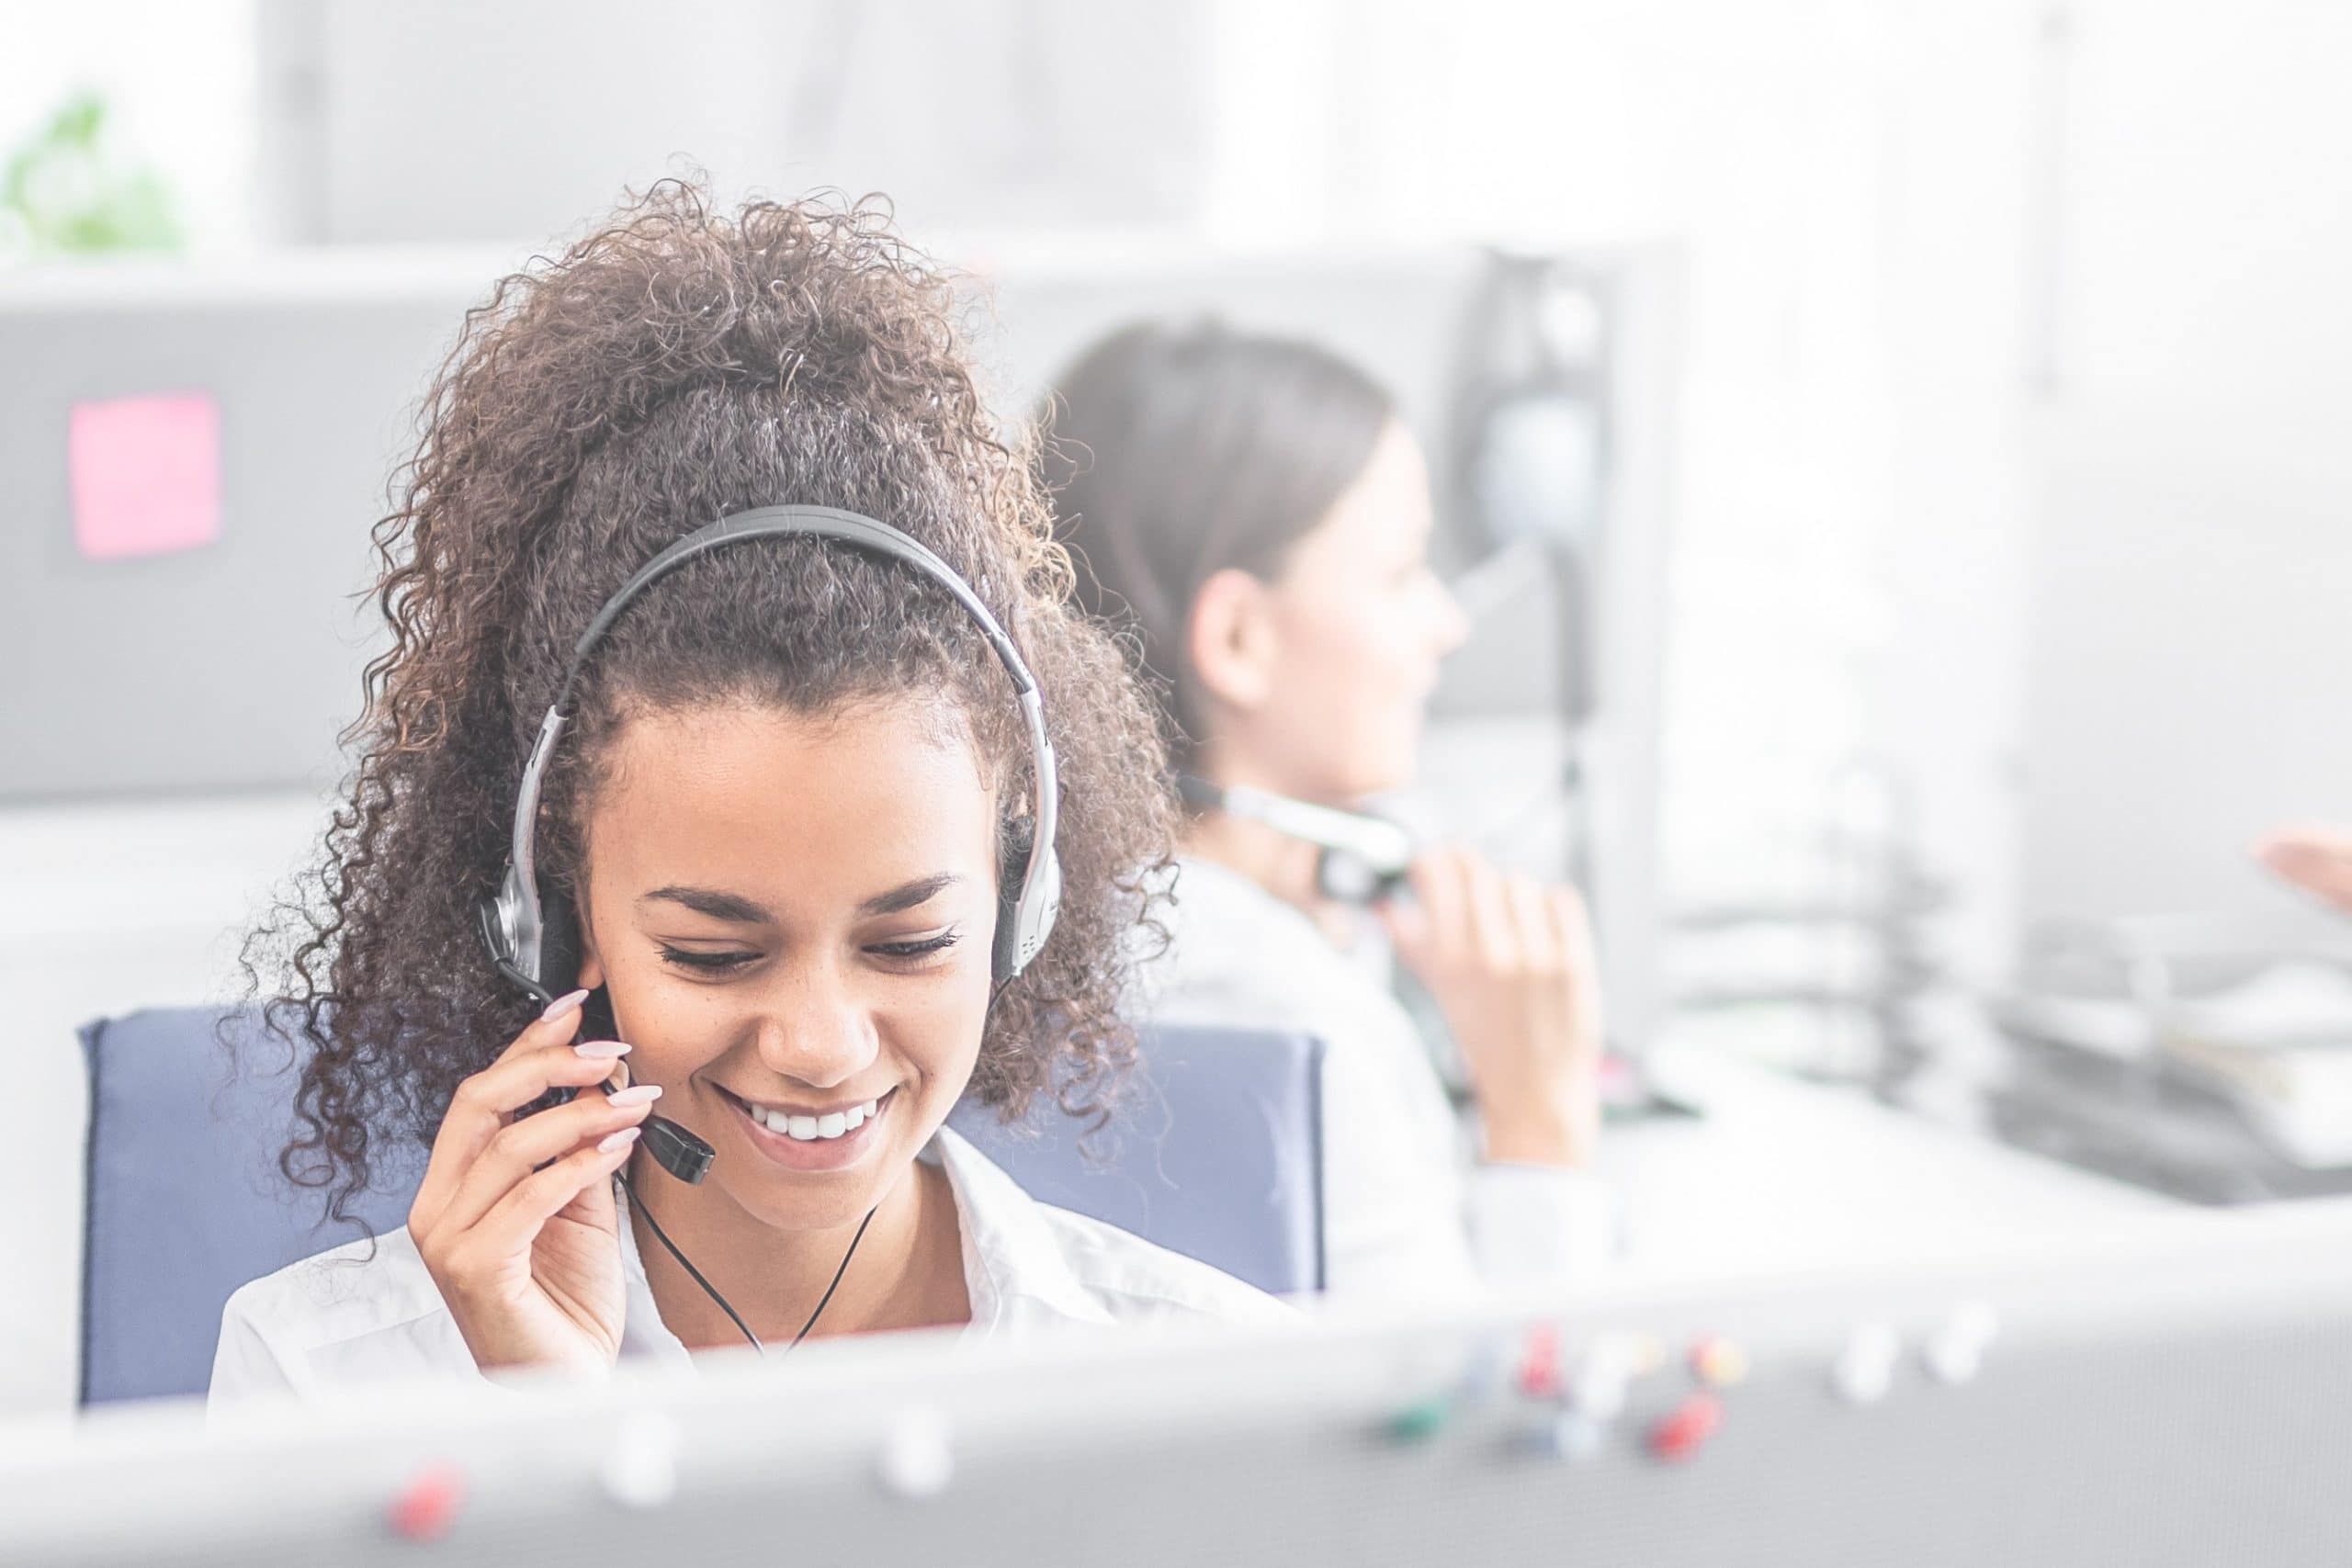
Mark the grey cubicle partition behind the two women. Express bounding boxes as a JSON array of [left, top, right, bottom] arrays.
[[0, 243, 1675, 1066]]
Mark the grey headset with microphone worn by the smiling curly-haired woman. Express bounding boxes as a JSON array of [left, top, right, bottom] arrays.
[[480, 505, 1061, 1189]]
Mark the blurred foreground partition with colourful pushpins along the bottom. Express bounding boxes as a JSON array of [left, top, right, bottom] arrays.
[[18, 1201, 2352, 1568]]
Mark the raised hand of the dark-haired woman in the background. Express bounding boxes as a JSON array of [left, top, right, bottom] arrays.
[[1381, 849, 1601, 1166]]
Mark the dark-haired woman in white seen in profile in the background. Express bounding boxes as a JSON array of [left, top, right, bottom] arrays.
[[1046, 324, 1609, 1295]]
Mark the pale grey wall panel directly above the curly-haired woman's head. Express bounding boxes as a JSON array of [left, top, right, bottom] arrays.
[[277, 0, 1202, 243]]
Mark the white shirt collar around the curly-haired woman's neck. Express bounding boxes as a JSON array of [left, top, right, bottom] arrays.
[[618, 1126, 1117, 1363]]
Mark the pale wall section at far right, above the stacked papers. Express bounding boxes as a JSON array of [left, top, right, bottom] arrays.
[[2023, 0, 2352, 915]]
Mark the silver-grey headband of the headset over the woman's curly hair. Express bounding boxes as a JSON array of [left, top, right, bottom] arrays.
[[482, 505, 1061, 992]]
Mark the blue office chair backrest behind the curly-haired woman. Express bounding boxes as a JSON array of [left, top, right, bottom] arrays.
[[83, 1009, 1322, 1405]]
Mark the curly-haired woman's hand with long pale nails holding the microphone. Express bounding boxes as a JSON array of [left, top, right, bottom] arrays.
[[409, 997, 661, 1371]]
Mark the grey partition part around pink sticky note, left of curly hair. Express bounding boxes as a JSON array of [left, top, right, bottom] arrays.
[[0, 259, 494, 802]]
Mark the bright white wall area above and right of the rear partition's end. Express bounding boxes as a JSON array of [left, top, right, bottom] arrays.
[[1270, 0, 2034, 978]]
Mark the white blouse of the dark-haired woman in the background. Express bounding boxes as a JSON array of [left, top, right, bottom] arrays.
[[1138, 856, 1613, 1295]]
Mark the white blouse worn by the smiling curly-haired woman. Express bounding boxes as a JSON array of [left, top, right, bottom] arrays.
[[211, 1128, 1294, 1405]]
